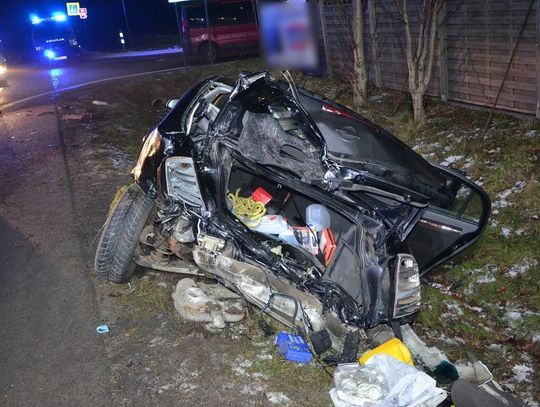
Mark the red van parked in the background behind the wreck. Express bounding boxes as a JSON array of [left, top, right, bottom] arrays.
[[182, 0, 259, 62]]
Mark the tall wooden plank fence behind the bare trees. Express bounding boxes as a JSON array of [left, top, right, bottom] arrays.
[[319, 0, 540, 119]]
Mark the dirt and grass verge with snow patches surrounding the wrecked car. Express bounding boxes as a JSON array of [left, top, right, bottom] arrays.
[[53, 61, 540, 406]]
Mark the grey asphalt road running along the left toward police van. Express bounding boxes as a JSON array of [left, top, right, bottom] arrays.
[[0, 51, 188, 406]]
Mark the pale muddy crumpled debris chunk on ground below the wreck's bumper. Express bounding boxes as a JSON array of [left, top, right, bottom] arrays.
[[172, 278, 247, 329]]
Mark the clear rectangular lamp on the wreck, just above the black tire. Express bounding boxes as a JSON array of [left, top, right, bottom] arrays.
[[165, 157, 203, 207]]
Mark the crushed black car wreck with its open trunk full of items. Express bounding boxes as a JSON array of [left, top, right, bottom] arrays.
[[95, 72, 490, 346]]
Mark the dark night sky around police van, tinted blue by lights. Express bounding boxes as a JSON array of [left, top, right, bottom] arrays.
[[0, 0, 177, 52]]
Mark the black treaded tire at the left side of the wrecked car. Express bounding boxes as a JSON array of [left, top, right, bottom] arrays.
[[95, 184, 154, 283]]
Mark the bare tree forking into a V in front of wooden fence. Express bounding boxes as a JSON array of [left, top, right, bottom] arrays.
[[395, 0, 442, 125]]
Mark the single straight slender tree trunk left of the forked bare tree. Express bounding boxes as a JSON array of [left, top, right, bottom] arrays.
[[353, 0, 367, 110]]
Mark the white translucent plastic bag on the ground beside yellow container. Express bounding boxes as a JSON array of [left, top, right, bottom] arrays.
[[330, 354, 447, 407]]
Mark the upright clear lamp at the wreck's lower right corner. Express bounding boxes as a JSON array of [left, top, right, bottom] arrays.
[[393, 254, 420, 318]]
